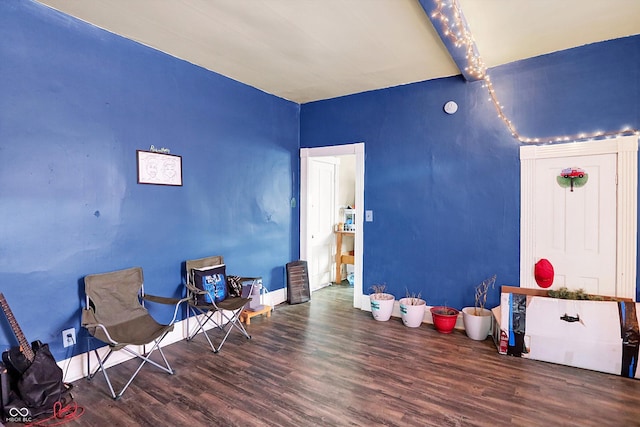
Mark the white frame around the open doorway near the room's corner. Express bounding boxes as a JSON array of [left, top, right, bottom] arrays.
[[300, 142, 368, 308]]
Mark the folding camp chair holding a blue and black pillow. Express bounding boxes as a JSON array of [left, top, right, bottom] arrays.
[[185, 255, 261, 353]]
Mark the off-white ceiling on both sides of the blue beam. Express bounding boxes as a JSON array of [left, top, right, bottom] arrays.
[[38, 0, 640, 103]]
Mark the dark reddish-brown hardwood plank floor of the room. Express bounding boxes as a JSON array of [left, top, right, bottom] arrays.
[[42, 285, 640, 427]]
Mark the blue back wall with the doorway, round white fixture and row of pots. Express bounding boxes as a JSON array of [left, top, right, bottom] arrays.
[[300, 36, 640, 308]]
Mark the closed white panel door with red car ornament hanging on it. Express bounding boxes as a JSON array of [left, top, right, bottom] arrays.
[[534, 154, 617, 295]]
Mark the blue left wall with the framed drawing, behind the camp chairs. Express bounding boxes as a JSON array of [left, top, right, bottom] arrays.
[[0, 0, 300, 360]]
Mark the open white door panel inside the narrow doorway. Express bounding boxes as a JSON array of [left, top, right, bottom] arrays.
[[308, 158, 337, 291]]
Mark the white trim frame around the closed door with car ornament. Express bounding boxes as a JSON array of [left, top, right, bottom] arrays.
[[520, 135, 638, 301]]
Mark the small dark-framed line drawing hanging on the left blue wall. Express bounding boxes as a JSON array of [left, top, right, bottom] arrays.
[[136, 150, 182, 185]]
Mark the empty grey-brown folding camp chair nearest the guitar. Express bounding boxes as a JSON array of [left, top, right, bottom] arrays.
[[82, 267, 186, 399]]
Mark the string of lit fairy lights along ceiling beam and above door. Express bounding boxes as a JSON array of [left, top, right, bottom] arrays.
[[431, 0, 640, 144]]
